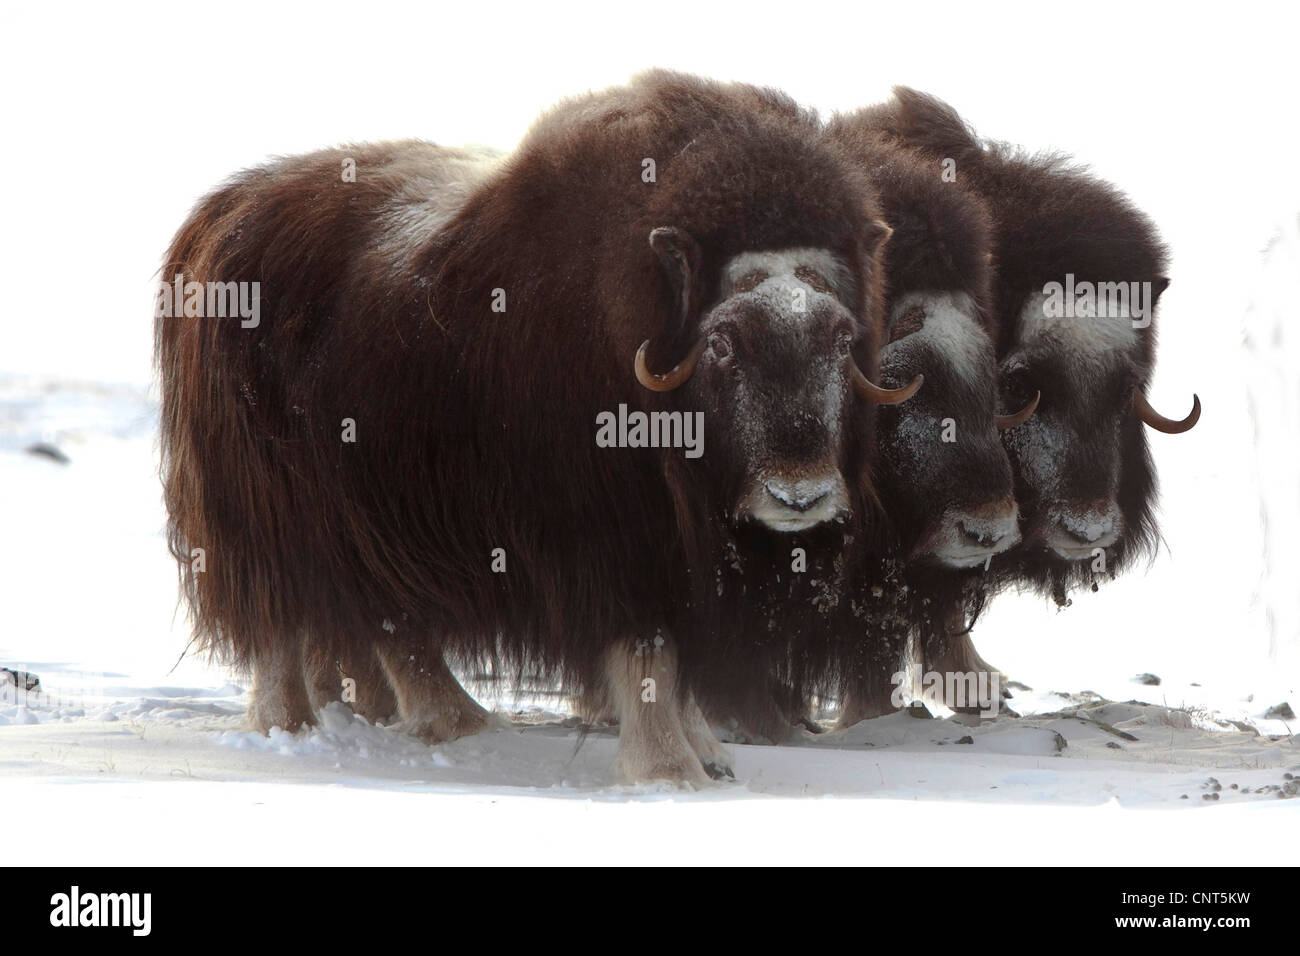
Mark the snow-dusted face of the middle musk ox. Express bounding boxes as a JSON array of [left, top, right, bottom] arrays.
[[876, 293, 1032, 567]]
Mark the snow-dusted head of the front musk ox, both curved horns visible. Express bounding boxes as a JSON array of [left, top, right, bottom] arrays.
[[636, 228, 920, 533]]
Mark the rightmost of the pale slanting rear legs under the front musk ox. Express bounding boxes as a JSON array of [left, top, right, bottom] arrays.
[[376, 637, 495, 744]]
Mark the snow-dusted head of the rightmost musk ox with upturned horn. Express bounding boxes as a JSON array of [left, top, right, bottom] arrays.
[[1000, 290, 1200, 587]]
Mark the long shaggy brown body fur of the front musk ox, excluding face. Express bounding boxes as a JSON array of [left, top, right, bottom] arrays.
[[156, 73, 883, 712]]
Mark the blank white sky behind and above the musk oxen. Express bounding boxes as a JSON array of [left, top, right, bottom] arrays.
[[0, 0, 1300, 686]]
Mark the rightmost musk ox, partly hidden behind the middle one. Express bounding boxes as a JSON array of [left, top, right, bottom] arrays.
[[863, 87, 1200, 702]]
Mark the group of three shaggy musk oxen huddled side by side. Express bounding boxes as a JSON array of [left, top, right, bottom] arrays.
[[155, 72, 1200, 784]]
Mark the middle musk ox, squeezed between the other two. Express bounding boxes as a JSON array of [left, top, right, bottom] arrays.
[[702, 125, 1034, 740]]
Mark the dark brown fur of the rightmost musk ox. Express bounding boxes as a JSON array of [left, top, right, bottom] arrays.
[[866, 87, 1167, 712]]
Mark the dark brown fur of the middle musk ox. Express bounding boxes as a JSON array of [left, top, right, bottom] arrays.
[[829, 117, 1013, 723]]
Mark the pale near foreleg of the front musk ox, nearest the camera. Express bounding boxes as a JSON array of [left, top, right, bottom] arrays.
[[605, 636, 709, 786]]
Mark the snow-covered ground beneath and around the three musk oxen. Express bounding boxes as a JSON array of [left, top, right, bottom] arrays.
[[0, 377, 1300, 864]]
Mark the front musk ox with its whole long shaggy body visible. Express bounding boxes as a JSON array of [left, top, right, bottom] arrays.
[[156, 73, 915, 780]]
